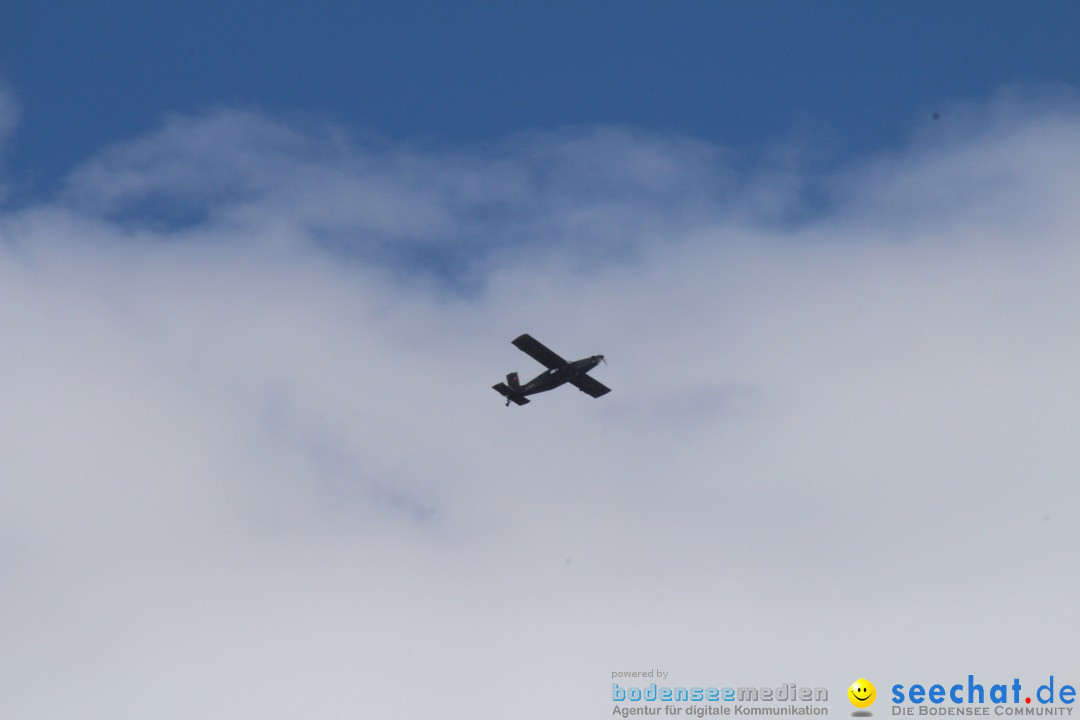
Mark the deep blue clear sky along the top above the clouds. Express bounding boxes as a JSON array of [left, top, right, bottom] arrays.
[[6, 0, 1080, 193]]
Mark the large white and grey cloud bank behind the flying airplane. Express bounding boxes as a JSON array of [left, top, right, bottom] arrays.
[[0, 92, 1080, 718]]
